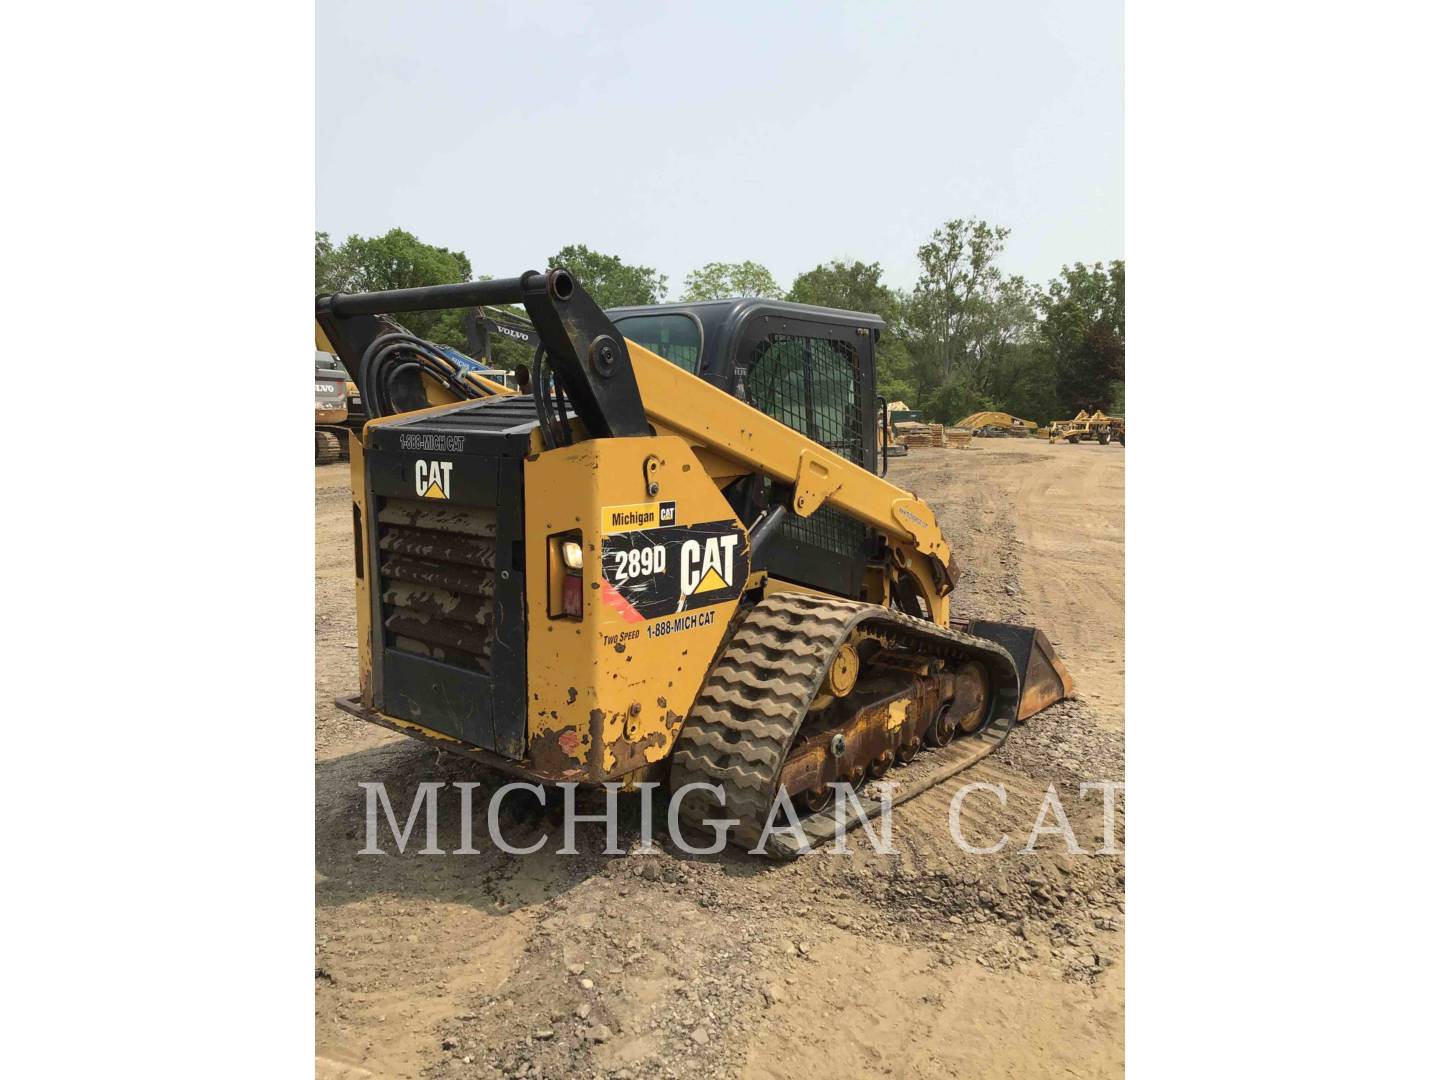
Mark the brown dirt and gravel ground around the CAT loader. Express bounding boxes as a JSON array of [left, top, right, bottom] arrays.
[[315, 439, 1126, 1079]]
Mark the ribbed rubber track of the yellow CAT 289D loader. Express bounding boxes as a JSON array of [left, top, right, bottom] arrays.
[[670, 593, 1020, 858]]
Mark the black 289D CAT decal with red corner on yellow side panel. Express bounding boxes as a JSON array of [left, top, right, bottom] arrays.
[[600, 521, 750, 622]]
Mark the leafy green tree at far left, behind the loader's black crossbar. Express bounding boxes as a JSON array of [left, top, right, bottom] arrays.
[[315, 229, 472, 347]]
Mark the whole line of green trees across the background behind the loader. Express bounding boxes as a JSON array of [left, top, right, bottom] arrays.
[[315, 217, 1125, 423]]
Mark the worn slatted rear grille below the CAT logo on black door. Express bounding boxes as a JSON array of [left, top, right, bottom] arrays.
[[379, 498, 497, 674]]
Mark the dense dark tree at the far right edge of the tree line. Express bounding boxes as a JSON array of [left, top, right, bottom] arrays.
[[1040, 261, 1125, 415]]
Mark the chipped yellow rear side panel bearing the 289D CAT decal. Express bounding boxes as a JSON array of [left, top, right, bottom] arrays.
[[526, 436, 749, 780]]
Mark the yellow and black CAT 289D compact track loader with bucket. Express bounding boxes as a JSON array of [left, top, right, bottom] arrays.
[[324, 269, 1073, 858]]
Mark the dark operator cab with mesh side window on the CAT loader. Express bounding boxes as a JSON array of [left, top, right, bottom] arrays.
[[605, 297, 884, 598]]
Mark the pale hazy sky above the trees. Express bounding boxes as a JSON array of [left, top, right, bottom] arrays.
[[315, 0, 1125, 300]]
